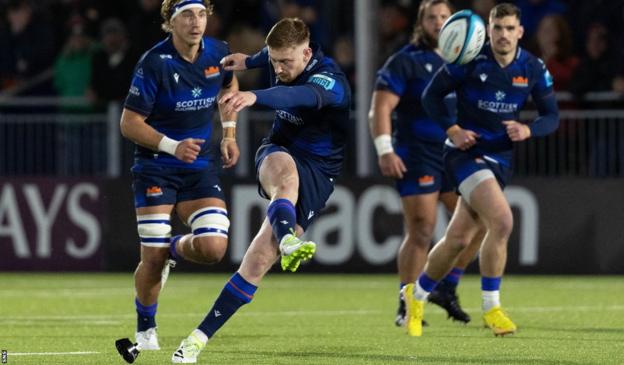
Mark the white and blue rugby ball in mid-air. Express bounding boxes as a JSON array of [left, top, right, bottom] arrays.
[[438, 10, 485, 65]]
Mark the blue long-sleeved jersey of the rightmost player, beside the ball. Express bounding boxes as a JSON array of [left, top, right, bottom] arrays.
[[422, 43, 559, 166]]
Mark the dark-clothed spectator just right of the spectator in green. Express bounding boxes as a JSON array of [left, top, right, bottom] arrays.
[[89, 18, 138, 106]]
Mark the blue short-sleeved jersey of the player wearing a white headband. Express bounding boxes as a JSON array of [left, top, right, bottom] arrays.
[[124, 37, 233, 171]]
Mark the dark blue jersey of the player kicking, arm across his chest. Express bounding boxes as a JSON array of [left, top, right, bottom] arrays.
[[246, 44, 351, 176]]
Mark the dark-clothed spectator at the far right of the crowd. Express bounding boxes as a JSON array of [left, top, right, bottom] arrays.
[[570, 23, 619, 97]]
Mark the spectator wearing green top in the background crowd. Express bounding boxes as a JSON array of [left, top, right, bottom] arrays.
[[54, 23, 95, 106]]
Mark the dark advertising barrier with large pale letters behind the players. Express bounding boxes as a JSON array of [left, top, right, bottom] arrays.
[[0, 178, 624, 274]]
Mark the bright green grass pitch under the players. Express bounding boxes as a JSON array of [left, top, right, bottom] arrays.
[[0, 268, 624, 365]]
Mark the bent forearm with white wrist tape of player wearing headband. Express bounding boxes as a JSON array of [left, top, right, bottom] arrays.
[[120, 108, 205, 163]]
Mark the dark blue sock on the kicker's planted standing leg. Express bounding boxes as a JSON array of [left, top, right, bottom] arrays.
[[197, 272, 258, 338]]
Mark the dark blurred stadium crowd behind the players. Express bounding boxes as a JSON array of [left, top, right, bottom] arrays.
[[0, 0, 624, 104]]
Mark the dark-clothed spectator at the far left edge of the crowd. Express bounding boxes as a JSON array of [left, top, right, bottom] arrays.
[[0, 0, 56, 95]]
